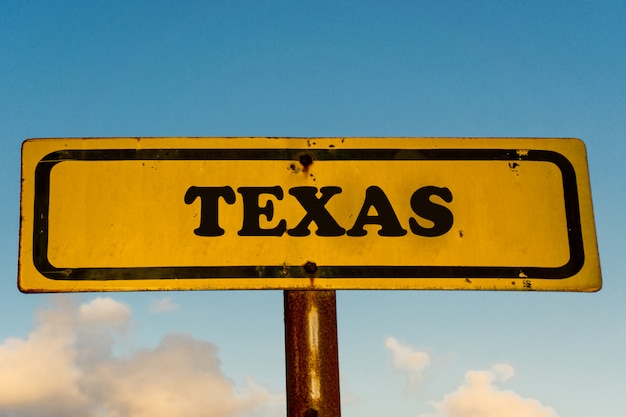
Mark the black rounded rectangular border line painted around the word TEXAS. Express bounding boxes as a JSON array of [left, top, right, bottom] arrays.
[[33, 148, 585, 281]]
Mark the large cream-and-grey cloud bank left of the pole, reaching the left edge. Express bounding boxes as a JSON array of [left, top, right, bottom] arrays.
[[0, 297, 285, 417]]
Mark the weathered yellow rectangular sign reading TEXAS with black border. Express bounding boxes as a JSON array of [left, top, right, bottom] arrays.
[[18, 138, 601, 292]]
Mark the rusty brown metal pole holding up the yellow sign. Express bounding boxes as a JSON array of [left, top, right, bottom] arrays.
[[284, 290, 341, 417]]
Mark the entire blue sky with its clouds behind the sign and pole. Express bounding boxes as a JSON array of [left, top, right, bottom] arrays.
[[0, 0, 626, 417]]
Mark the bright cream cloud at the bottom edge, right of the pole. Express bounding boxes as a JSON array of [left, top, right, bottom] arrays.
[[420, 363, 558, 417]]
